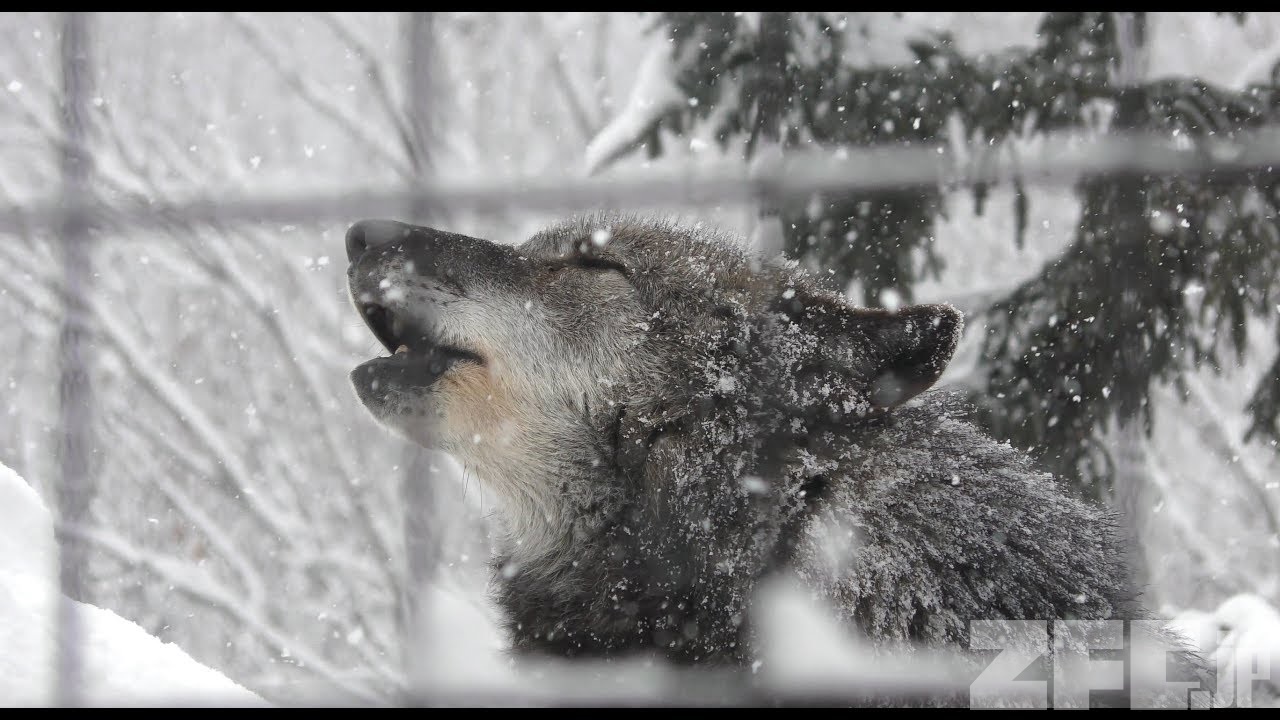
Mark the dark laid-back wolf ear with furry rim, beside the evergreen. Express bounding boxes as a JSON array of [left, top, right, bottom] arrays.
[[849, 299, 964, 410]]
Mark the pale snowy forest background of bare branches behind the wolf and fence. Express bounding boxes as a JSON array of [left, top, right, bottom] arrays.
[[0, 13, 1280, 701]]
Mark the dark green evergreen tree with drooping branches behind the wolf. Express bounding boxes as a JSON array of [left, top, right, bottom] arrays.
[[588, 13, 1280, 496]]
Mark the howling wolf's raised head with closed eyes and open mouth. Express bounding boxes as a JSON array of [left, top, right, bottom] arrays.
[[347, 215, 961, 558]]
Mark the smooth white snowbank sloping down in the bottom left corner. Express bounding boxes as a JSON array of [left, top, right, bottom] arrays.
[[0, 465, 265, 706]]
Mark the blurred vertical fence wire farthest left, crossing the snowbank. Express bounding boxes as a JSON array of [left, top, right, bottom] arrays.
[[55, 13, 93, 707]]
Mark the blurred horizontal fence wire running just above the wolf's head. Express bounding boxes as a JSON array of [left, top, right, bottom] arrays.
[[0, 126, 1280, 232]]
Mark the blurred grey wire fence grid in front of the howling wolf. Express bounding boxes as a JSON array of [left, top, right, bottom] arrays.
[[32, 13, 1280, 706]]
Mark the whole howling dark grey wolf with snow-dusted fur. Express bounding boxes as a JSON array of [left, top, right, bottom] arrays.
[[347, 215, 1137, 664]]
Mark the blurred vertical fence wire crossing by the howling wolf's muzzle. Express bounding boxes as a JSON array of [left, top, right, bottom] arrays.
[[401, 13, 442, 705]]
